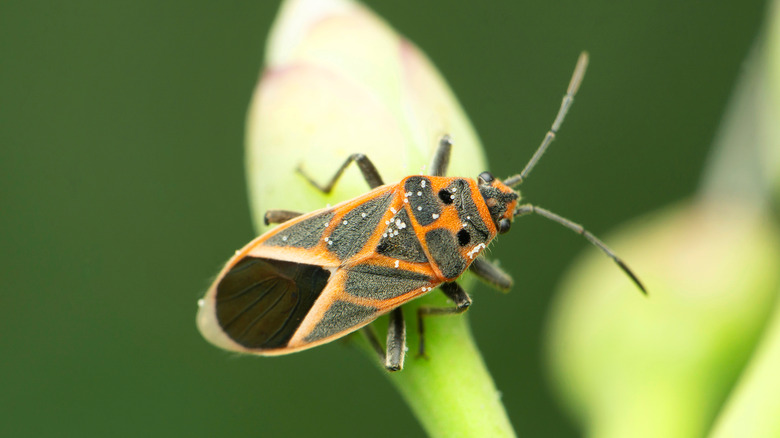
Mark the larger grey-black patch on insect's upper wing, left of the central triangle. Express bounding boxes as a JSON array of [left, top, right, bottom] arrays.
[[327, 192, 393, 260]]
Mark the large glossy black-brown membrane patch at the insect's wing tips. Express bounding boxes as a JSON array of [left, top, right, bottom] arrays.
[[216, 257, 330, 349]]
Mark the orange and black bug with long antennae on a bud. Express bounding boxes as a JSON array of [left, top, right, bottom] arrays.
[[197, 52, 644, 371]]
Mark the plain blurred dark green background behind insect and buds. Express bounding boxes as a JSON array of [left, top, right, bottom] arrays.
[[0, 0, 765, 437]]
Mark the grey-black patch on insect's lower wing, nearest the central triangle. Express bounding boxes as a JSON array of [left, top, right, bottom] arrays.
[[344, 264, 431, 300]]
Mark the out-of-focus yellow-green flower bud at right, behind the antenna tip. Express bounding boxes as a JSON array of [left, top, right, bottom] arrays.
[[548, 201, 780, 437]]
